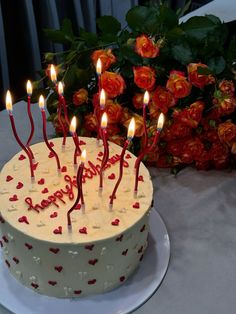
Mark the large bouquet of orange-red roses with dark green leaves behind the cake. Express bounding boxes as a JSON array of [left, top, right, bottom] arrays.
[[34, 4, 236, 169]]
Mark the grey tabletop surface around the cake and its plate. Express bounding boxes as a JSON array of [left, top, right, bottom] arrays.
[[0, 102, 236, 314]]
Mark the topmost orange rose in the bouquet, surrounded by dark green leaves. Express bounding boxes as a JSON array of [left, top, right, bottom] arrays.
[[135, 35, 160, 58]]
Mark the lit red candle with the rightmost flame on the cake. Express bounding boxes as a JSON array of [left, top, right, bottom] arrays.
[[134, 113, 164, 193]]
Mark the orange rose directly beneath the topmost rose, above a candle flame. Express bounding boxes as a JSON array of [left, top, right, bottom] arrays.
[[133, 66, 156, 90]]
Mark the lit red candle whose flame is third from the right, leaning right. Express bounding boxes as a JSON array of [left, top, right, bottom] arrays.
[[109, 118, 135, 208]]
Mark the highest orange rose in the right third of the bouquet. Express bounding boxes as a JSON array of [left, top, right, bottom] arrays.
[[187, 63, 215, 88]]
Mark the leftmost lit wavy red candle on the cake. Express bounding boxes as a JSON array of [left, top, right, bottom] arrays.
[[6, 91, 34, 182]]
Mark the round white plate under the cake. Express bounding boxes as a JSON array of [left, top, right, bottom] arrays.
[[0, 209, 170, 314]]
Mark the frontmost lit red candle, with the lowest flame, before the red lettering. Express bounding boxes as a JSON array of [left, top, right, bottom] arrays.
[[67, 149, 86, 228]]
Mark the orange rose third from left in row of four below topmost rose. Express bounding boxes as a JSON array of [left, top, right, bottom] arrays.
[[166, 71, 192, 98]]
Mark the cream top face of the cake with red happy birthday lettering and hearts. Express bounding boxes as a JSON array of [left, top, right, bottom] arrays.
[[0, 138, 153, 244]]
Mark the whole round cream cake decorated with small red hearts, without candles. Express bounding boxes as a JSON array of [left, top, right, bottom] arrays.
[[0, 138, 153, 298]]
